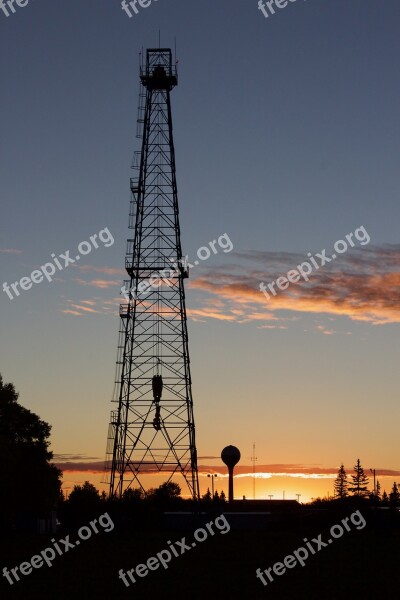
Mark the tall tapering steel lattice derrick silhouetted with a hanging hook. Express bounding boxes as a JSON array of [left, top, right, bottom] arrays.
[[107, 48, 199, 499]]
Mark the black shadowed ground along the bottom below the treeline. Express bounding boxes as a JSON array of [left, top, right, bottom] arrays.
[[0, 515, 400, 600]]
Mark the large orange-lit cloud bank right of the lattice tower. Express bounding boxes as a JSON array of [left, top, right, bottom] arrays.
[[190, 245, 400, 326]]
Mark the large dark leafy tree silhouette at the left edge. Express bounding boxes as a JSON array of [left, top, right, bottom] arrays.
[[0, 375, 62, 526]]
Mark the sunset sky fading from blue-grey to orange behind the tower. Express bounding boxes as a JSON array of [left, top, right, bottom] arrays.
[[0, 0, 400, 501]]
